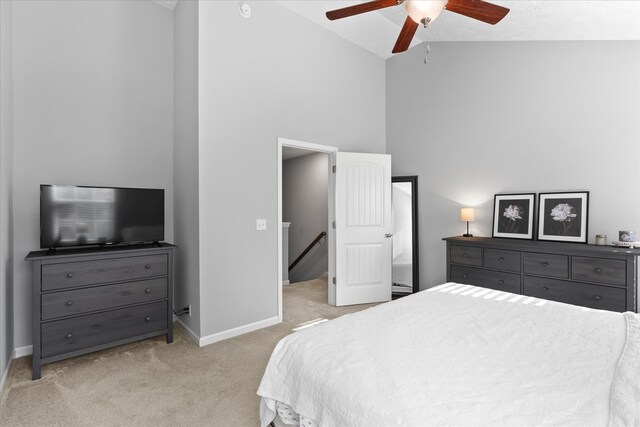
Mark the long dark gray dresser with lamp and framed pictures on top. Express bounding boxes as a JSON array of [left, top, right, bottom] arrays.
[[443, 237, 640, 313]]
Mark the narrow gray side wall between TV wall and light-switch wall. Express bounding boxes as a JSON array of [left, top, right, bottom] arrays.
[[173, 1, 201, 334]]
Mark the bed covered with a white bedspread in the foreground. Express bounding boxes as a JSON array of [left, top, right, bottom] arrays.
[[258, 283, 640, 427]]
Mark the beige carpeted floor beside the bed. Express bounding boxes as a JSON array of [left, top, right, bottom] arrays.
[[0, 279, 378, 427]]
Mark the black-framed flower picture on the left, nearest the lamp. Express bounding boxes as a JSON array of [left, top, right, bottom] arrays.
[[492, 193, 536, 240]]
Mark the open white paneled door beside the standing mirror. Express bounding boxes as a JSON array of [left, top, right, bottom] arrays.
[[335, 152, 392, 305]]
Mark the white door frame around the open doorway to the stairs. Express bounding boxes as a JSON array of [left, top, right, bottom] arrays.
[[277, 137, 338, 322]]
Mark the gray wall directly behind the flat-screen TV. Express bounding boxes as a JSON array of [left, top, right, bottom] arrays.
[[13, 1, 173, 347]]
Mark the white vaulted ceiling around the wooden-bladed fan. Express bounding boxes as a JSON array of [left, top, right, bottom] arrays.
[[276, 0, 640, 58]]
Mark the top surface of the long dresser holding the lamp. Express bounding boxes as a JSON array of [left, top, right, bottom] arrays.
[[442, 236, 640, 256]]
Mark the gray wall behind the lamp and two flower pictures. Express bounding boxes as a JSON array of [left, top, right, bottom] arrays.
[[386, 41, 640, 289]]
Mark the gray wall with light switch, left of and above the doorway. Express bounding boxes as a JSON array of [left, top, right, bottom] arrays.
[[199, 1, 385, 336]]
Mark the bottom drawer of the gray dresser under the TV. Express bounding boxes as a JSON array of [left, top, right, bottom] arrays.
[[40, 301, 167, 358]]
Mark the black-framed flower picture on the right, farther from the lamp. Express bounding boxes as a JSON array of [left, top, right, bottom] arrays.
[[538, 191, 589, 243]]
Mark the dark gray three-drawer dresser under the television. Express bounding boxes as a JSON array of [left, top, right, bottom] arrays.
[[26, 243, 176, 380]]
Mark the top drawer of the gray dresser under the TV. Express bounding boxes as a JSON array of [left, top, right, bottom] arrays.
[[42, 254, 167, 291]]
